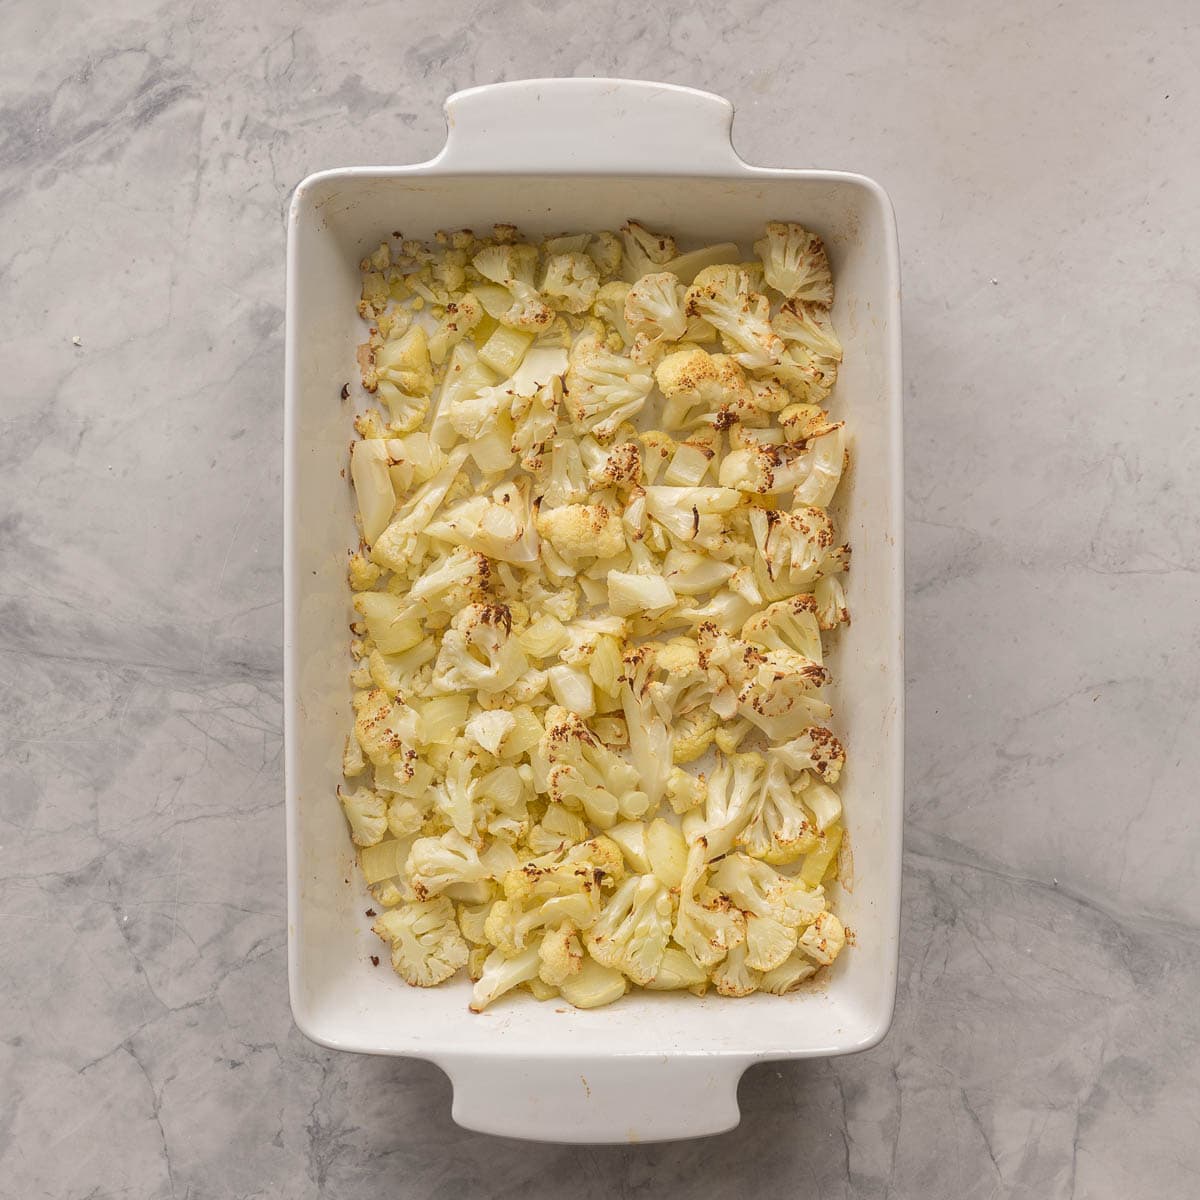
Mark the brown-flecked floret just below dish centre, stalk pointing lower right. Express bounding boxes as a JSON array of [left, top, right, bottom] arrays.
[[532, 704, 649, 829]]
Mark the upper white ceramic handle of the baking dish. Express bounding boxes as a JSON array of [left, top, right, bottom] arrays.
[[436, 79, 744, 175]]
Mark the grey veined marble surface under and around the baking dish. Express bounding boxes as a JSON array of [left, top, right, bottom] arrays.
[[0, 0, 1200, 1200]]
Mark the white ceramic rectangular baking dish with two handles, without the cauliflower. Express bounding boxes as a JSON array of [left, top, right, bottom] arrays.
[[284, 79, 904, 1142]]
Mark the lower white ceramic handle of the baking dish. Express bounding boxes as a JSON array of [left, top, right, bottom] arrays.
[[436, 1055, 751, 1144]]
